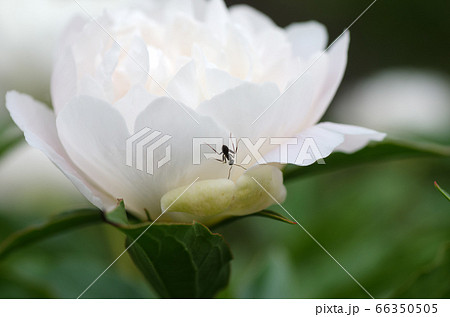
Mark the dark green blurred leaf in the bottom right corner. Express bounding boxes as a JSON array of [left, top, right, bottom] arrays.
[[392, 242, 450, 298]]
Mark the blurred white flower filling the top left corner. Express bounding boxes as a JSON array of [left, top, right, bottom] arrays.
[[0, 0, 124, 108]]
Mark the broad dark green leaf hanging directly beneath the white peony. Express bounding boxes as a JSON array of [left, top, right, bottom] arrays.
[[105, 201, 232, 298]]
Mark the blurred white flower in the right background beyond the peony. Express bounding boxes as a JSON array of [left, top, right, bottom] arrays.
[[331, 69, 450, 137]]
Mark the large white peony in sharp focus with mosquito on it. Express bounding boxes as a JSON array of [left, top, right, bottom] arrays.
[[7, 0, 384, 224]]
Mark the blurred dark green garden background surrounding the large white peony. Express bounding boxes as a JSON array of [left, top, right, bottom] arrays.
[[0, 0, 450, 298]]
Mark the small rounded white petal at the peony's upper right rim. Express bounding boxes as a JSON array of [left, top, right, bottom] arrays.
[[286, 21, 328, 60]]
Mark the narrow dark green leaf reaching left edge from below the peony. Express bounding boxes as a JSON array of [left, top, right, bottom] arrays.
[[0, 209, 104, 260]]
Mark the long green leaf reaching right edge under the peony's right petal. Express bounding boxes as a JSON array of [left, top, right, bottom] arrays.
[[283, 138, 450, 181]]
